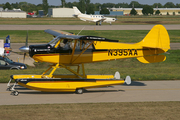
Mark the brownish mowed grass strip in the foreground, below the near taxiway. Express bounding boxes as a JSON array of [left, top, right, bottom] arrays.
[[0, 102, 180, 120]]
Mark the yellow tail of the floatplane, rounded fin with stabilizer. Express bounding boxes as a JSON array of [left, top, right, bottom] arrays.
[[137, 25, 170, 63]]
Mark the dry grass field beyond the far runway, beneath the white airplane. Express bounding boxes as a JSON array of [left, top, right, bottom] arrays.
[[0, 16, 180, 25]]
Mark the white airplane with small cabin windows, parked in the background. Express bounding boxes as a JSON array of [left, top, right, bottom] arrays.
[[73, 7, 117, 25]]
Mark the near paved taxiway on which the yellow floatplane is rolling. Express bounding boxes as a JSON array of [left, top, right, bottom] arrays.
[[0, 80, 180, 105]]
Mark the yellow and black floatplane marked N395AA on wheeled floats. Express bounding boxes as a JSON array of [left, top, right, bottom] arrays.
[[8, 25, 170, 95]]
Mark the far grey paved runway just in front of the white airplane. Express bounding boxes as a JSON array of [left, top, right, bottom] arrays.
[[0, 25, 180, 30]]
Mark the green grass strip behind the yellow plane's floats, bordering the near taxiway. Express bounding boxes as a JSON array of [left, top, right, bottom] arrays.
[[0, 50, 180, 83]]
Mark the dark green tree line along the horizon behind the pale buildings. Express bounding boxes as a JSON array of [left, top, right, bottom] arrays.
[[0, 0, 180, 14]]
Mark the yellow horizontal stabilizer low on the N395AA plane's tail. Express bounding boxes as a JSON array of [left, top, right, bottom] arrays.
[[137, 55, 166, 63]]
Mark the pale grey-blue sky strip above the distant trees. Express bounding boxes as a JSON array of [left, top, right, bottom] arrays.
[[0, 0, 180, 5]]
